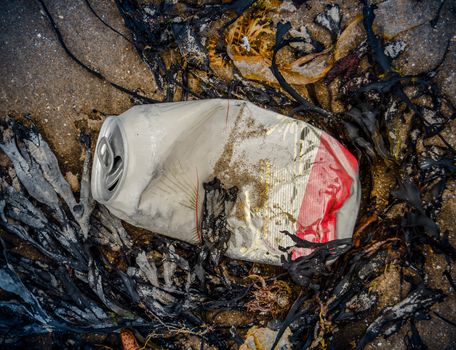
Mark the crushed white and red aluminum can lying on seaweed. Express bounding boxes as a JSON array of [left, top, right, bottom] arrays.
[[91, 99, 360, 265]]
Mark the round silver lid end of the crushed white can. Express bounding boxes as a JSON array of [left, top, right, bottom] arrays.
[[92, 117, 126, 203]]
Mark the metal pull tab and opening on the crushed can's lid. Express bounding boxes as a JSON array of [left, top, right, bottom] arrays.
[[97, 136, 123, 191]]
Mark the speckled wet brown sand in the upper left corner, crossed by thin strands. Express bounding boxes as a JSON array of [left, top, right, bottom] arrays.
[[0, 0, 155, 172]]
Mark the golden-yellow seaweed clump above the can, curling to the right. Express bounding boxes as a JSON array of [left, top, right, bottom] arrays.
[[219, 0, 364, 86]]
